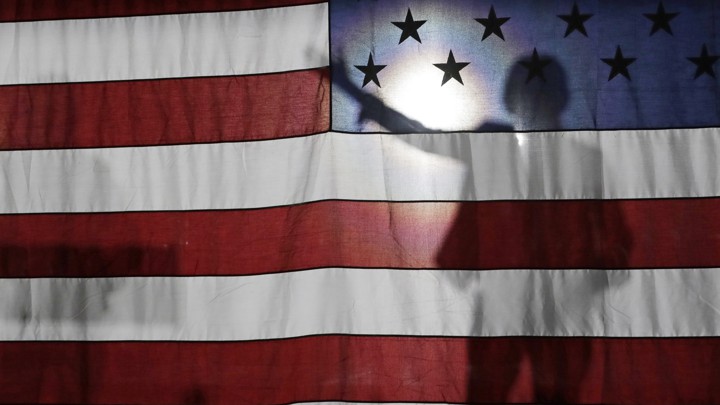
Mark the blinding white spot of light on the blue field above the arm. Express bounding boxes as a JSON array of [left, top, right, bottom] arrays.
[[383, 56, 484, 131]]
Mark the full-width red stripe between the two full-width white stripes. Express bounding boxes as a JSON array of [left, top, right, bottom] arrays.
[[0, 198, 720, 277]]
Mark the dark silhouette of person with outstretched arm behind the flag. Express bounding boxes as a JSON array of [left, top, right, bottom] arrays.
[[333, 52, 632, 403]]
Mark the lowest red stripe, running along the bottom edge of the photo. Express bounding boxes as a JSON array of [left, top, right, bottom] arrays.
[[0, 336, 720, 405]]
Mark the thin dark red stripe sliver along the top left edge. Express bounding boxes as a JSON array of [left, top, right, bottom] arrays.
[[0, 0, 319, 22]]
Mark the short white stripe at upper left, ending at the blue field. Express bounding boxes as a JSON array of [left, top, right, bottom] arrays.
[[0, 4, 329, 84]]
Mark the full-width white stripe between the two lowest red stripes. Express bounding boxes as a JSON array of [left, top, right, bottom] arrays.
[[0, 268, 720, 340]]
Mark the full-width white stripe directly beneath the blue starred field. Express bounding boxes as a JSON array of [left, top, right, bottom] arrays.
[[0, 128, 720, 213]]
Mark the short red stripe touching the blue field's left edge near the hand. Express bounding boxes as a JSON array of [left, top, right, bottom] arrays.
[[0, 69, 330, 149]]
